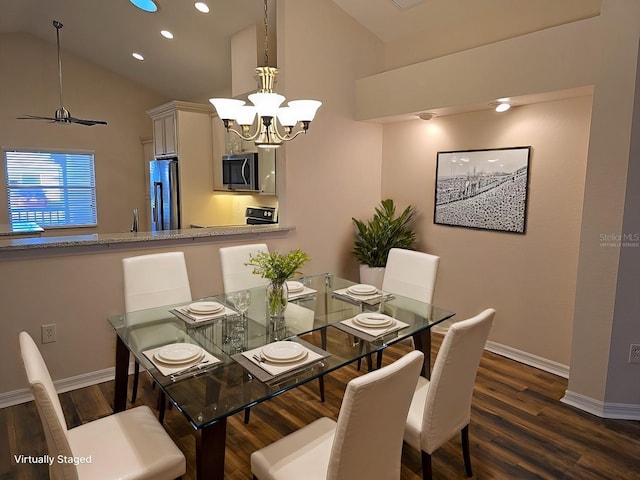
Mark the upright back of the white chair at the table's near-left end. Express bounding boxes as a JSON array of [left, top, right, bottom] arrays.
[[19, 332, 78, 480]]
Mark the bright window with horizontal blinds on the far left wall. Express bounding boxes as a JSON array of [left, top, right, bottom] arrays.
[[4, 150, 97, 230]]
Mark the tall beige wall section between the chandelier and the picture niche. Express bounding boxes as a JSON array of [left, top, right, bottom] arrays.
[[278, 0, 383, 279]]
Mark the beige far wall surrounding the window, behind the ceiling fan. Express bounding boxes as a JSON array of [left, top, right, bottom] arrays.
[[0, 33, 166, 234]]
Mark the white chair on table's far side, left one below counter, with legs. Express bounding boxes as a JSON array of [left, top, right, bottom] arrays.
[[122, 252, 192, 422]]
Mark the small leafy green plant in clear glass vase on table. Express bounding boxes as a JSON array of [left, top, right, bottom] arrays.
[[246, 248, 310, 317]]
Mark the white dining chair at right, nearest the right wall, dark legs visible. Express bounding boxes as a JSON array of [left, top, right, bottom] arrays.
[[404, 308, 495, 480]]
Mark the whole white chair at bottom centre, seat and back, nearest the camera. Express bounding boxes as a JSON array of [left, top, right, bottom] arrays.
[[251, 350, 424, 480]]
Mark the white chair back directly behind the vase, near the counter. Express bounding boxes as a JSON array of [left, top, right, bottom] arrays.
[[220, 243, 269, 293]]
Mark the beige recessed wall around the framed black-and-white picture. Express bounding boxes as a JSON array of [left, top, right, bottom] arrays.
[[382, 97, 592, 365]]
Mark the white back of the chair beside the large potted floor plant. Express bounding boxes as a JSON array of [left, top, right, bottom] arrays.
[[382, 248, 440, 303]]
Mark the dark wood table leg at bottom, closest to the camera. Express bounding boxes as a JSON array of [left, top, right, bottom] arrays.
[[196, 417, 227, 480]]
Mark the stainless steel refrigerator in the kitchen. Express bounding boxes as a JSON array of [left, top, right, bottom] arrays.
[[149, 158, 181, 232]]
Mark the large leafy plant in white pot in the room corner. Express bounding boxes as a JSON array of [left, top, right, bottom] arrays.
[[352, 198, 416, 288]]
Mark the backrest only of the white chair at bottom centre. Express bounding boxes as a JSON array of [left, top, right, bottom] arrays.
[[327, 350, 424, 480]]
